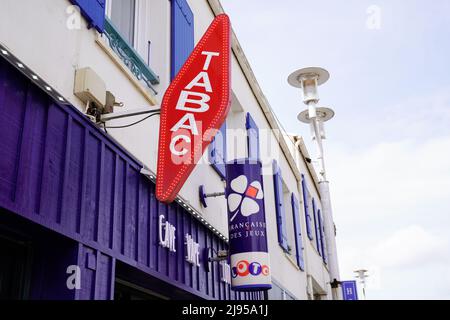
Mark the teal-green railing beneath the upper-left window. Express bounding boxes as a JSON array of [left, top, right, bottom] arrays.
[[105, 18, 159, 94]]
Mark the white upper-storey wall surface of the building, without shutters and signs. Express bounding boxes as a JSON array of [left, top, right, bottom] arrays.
[[0, 0, 329, 299]]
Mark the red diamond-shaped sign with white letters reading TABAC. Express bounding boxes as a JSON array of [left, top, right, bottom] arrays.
[[156, 14, 231, 202]]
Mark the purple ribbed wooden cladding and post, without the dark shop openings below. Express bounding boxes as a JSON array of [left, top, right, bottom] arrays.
[[0, 59, 264, 299]]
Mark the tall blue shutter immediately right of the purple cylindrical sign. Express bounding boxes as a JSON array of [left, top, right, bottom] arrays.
[[273, 160, 288, 251]]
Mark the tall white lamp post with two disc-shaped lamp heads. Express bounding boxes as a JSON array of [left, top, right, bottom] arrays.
[[288, 68, 342, 299]]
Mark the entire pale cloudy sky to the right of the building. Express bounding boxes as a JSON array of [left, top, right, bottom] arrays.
[[221, 0, 450, 299]]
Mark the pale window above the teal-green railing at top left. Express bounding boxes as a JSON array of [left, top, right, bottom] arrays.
[[110, 0, 136, 47]]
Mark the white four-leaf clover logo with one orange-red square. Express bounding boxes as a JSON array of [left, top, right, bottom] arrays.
[[227, 175, 264, 222]]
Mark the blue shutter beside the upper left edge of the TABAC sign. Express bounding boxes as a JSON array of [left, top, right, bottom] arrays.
[[170, 0, 194, 79]]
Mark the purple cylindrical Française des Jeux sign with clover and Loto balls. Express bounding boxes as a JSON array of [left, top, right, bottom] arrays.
[[226, 159, 272, 291]]
